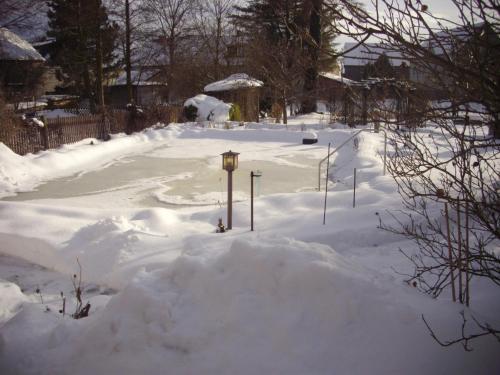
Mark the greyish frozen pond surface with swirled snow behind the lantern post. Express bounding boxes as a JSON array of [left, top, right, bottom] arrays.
[[5, 145, 318, 208]]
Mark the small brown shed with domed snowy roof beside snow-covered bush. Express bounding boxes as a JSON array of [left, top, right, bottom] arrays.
[[204, 73, 263, 122]]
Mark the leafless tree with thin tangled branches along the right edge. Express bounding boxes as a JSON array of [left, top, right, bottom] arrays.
[[330, 0, 500, 350]]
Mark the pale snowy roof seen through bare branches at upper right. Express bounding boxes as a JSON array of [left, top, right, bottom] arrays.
[[344, 42, 408, 66]]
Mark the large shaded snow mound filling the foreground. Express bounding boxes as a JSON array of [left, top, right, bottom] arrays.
[[0, 237, 492, 375]]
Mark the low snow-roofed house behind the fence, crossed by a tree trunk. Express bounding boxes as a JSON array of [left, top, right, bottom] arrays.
[[107, 69, 167, 107]]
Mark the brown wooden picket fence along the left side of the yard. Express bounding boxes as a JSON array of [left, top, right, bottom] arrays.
[[0, 109, 178, 155]]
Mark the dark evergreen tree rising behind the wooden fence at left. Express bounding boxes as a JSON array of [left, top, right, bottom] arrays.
[[48, 0, 118, 104]]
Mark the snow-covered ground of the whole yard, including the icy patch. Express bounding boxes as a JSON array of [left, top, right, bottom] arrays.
[[0, 116, 500, 374]]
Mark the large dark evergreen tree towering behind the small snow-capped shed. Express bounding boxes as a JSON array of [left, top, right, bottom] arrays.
[[235, 0, 335, 116]]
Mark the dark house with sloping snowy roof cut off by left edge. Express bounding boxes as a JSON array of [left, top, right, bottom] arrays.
[[0, 28, 45, 102]]
